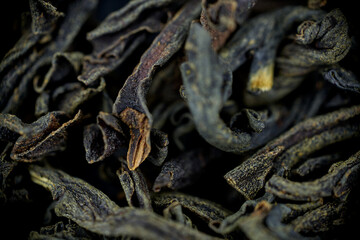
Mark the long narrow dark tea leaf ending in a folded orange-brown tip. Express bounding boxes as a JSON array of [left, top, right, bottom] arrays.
[[113, 1, 200, 170]]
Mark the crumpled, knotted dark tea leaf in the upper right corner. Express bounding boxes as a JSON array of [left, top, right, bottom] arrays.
[[277, 9, 351, 76]]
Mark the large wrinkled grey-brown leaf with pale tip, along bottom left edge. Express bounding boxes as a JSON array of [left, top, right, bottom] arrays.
[[29, 165, 217, 239]]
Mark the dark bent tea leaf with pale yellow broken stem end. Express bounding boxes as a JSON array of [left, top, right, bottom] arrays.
[[220, 6, 322, 92]]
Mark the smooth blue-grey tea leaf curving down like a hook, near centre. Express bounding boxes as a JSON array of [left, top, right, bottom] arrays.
[[181, 23, 252, 153]]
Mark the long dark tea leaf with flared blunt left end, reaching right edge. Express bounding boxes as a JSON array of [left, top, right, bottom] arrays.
[[224, 106, 360, 199]]
